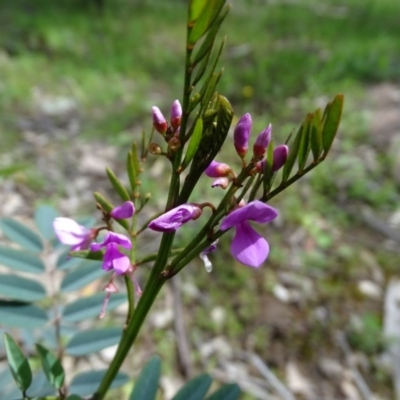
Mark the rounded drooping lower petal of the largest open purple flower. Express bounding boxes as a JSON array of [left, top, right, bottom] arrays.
[[231, 221, 269, 268]]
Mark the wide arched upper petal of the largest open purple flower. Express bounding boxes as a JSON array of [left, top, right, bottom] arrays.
[[221, 200, 278, 231]]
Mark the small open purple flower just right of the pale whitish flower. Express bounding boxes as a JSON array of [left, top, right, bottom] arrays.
[[90, 231, 132, 275]]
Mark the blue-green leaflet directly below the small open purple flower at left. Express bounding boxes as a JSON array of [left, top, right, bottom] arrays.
[[61, 261, 104, 293]]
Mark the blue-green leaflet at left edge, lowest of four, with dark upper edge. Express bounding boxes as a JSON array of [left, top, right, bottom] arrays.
[[0, 300, 48, 329]]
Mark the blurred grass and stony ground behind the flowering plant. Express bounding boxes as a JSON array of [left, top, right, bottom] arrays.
[[0, 0, 400, 400]]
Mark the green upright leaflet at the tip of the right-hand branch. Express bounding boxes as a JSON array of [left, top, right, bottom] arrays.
[[322, 94, 344, 157]]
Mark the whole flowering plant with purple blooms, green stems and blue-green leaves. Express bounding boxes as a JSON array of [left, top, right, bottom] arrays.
[[0, 0, 343, 400]]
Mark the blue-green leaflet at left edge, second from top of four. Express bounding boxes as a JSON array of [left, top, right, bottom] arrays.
[[0, 246, 45, 274]]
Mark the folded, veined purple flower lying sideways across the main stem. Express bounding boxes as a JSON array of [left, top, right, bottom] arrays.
[[148, 203, 201, 232]]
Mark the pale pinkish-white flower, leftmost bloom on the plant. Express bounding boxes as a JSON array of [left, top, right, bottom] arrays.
[[53, 217, 93, 251]]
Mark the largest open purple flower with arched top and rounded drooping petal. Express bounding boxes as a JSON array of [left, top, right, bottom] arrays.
[[221, 200, 278, 267]]
